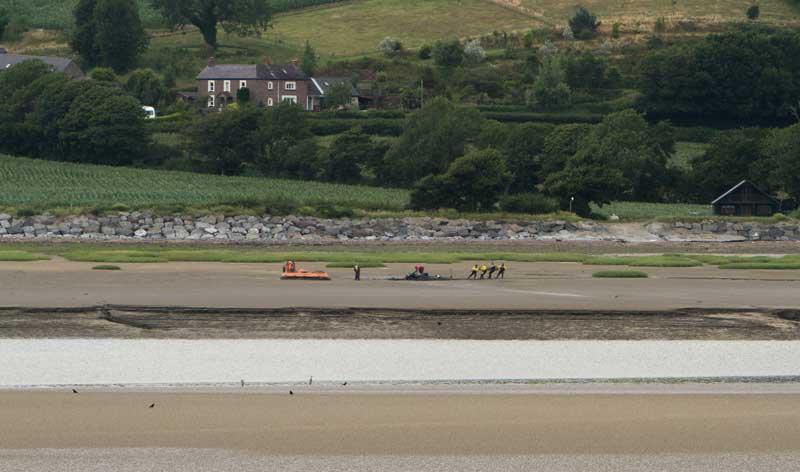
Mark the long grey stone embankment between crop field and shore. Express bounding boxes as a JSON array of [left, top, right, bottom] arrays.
[[0, 212, 800, 243]]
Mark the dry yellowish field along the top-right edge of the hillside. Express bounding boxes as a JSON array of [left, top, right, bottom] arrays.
[[506, 0, 800, 28]]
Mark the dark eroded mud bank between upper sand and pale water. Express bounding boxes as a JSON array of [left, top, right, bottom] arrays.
[[0, 306, 800, 340]]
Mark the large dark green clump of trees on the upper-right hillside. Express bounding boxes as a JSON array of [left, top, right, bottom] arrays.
[[639, 25, 800, 121]]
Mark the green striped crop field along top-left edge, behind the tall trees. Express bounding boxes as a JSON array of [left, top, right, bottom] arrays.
[[0, 0, 341, 29]]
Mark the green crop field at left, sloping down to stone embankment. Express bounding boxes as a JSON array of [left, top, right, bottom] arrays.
[[0, 155, 408, 210]]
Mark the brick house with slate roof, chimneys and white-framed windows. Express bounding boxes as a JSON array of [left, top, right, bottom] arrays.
[[197, 58, 318, 110]]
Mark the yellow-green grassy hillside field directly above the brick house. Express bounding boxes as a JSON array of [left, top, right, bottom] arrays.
[[267, 0, 541, 57]]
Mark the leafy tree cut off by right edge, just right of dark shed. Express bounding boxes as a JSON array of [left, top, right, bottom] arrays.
[[762, 123, 800, 202]]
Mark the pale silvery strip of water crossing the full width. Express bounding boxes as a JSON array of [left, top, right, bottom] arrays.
[[0, 339, 800, 387]]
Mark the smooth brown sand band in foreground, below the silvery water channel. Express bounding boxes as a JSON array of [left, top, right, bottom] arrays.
[[0, 387, 800, 457]]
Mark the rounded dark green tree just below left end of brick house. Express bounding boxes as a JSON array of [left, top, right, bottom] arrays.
[[189, 107, 262, 175]]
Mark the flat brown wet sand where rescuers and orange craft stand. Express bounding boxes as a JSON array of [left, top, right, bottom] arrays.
[[0, 261, 800, 311]]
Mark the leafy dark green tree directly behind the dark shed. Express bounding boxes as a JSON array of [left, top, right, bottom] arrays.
[[691, 128, 764, 201]]
